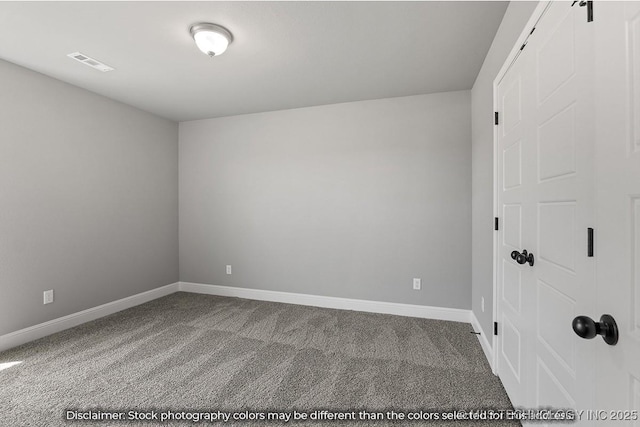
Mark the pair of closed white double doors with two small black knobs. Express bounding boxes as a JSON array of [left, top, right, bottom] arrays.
[[497, 2, 595, 409]]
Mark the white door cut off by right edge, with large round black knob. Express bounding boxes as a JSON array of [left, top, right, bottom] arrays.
[[585, 2, 640, 426]]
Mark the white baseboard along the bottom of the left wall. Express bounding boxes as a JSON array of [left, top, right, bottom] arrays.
[[0, 282, 180, 351]]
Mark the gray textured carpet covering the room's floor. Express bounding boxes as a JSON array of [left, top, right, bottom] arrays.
[[0, 292, 519, 426]]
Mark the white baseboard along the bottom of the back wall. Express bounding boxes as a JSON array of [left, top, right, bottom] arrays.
[[180, 282, 471, 323]]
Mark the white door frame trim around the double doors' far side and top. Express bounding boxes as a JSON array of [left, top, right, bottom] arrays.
[[490, 0, 553, 375]]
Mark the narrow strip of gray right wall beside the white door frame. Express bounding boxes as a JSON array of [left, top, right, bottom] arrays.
[[471, 1, 537, 343]]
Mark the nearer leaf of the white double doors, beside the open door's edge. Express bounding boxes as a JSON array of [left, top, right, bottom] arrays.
[[532, 2, 595, 418]]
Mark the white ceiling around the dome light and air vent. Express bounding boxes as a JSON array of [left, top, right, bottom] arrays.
[[0, 1, 507, 121]]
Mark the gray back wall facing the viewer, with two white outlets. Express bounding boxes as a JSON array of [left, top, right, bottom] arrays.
[[180, 91, 471, 309]]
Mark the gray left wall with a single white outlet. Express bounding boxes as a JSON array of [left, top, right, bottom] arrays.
[[0, 61, 178, 335]]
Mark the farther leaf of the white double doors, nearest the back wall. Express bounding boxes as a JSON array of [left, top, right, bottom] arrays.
[[497, 27, 535, 404]]
